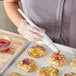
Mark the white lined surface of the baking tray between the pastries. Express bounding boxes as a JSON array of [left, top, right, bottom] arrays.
[[1, 42, 75, 76]]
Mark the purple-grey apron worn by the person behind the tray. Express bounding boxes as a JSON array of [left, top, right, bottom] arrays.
[[21, 0, 76, 47]]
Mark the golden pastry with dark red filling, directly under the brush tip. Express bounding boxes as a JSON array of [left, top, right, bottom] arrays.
[[48, 53, 66, 66]]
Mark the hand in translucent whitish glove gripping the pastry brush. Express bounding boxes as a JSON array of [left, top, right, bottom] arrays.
[[17, 20, 45, 41]]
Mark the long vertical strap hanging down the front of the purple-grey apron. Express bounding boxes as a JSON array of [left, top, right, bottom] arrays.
[[55, 0, 65, 42]]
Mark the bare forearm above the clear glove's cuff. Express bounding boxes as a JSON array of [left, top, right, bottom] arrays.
[[4, 1, 24, 27]]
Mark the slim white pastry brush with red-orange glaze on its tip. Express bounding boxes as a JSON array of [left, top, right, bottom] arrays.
[[18, 8, 60, 54]]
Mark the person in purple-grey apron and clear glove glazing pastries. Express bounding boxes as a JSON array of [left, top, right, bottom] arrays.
[[4, 0, 76, 48]]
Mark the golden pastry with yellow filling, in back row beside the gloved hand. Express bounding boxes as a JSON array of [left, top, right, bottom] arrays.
[[28, 45, 46, 58]]
